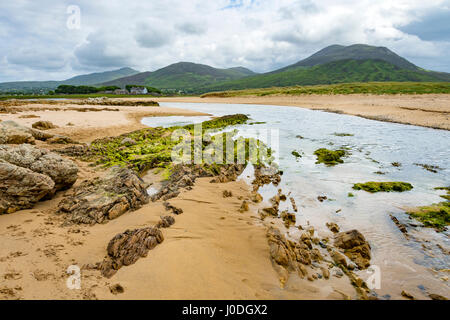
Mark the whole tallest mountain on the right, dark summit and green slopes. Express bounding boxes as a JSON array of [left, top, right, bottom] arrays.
[[197, 44, 450, 93]]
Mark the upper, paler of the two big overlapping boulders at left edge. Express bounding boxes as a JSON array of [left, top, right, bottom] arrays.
[[0, 144, 78, 191]]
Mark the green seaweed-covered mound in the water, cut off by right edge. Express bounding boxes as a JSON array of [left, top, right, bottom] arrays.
[[406, 201, 450, 231]]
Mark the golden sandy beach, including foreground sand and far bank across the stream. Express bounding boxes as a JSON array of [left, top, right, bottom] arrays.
[[0, 96, 449, 299]]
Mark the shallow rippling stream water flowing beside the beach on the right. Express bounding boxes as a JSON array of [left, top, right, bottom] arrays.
[[143, 103, 450, 297]]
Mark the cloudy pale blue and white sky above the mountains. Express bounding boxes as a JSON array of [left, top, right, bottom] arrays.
[[0, 0, 450, 82]]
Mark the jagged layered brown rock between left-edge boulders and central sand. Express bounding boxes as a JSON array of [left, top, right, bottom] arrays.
[[58, 167, 149, 224]]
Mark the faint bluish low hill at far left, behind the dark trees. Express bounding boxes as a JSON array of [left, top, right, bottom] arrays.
[[0, 68, 139, 91]]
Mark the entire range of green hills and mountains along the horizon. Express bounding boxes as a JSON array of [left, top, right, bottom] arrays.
[[0, 44, 450, 93]]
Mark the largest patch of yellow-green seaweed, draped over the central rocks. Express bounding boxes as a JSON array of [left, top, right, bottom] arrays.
[[85, 114, 272, 178]]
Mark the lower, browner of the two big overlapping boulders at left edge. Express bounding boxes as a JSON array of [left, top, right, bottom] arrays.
[[0, 159, 55, 214]]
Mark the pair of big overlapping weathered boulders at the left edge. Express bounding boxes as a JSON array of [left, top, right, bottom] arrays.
[[0, 144, 78, 214]]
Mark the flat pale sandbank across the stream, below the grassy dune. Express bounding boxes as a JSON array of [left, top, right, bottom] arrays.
[[154, 94, 450, 130]]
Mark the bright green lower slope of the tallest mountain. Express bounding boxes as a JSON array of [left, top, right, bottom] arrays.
[[197, 59, 450, 92]]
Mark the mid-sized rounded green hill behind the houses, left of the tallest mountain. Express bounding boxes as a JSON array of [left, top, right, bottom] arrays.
[[99, 62, 256, 91]]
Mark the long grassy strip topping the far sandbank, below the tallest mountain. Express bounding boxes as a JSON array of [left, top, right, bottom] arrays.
[[201, 82, 450, 98]]
